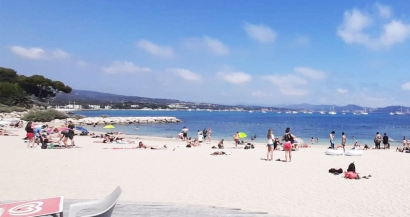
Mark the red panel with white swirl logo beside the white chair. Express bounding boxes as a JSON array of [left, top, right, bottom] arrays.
[[0, 197, 64, 217]]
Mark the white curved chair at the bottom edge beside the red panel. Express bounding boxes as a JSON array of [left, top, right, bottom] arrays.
[[68, 186, 122, 217]]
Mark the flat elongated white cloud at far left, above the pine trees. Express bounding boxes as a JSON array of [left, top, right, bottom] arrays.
[[10, 46, 70, 60]]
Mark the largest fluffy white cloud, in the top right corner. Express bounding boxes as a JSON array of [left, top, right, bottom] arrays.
[[337, 5, 410, 49]]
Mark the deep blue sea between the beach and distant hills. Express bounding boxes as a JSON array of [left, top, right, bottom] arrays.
[[75, 110, 410, 146]]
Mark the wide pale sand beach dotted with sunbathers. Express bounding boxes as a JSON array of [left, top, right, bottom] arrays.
[[0, 129, 410, 216]]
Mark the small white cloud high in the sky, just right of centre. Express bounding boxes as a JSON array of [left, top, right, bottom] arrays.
[[244, 23, 277, 44]]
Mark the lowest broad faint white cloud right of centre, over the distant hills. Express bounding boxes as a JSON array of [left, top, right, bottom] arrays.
[[265, 74, 309, 96]]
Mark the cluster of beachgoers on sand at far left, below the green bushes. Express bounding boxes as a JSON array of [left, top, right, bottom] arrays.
[[25, 121, 75, 149]]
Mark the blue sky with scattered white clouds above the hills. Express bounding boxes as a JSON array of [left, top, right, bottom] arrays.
[[0, 0, 410, 107]]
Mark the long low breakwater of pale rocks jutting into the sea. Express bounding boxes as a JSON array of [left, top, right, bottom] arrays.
[[51, 117, 182, 125]]
